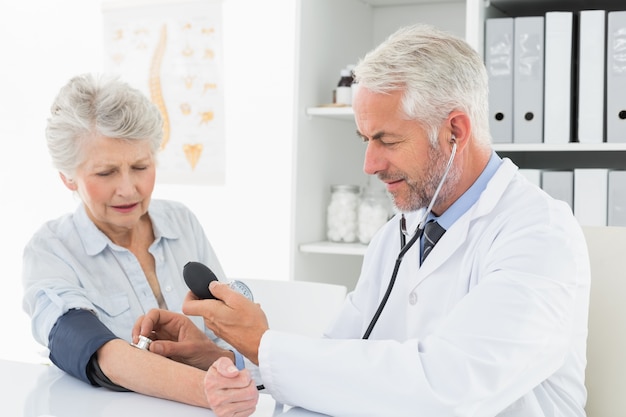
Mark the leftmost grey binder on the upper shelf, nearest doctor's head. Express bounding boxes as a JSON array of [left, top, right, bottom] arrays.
[[485, 17, 513, 143]]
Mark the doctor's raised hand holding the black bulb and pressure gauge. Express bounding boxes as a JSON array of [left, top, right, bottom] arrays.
[[183, 281, 269, 365]]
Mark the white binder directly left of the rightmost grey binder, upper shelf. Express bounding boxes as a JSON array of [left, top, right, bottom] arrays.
[[577, 10, 606, 143]]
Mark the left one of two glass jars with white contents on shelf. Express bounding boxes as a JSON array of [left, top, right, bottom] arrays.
[[326, 184, 360, 242]]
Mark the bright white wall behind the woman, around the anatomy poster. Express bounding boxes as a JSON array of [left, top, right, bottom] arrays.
[[0, 0, 296, 360]]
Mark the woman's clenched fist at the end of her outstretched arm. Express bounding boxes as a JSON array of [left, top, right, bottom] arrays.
[[204, 358, 259, 417]]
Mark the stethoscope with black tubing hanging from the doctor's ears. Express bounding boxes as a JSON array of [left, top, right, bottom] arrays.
[[363, 135, 456, 339]]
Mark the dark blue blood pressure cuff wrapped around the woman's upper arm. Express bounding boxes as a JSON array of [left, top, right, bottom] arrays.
[[48, 309, 128, 391]]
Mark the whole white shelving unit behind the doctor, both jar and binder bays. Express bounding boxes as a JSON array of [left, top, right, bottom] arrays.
[[291, 0, 626, 288]]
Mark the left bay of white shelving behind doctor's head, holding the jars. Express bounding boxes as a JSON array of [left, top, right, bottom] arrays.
[[290, 0, 466, 289]]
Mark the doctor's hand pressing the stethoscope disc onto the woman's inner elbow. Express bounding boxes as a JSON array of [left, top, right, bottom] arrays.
[[132, 309, 234, 370]]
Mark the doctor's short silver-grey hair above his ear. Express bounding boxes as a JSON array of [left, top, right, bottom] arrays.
[[354, 25, 491, 146]]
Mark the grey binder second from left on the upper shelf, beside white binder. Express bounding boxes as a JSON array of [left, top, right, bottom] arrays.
[[513, 16, 544, 143]]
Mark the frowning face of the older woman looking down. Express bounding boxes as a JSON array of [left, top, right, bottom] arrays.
[[62, 136, 156, 237]]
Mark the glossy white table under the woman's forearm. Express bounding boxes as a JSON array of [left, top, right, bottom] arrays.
[[0, 360, 322, 417]]
